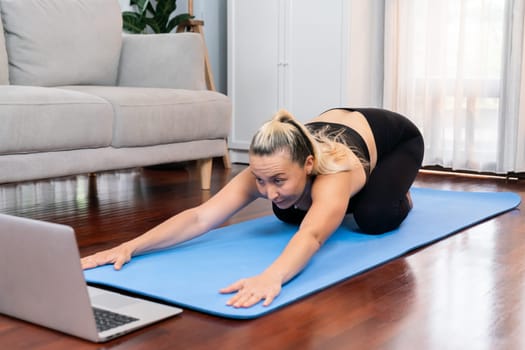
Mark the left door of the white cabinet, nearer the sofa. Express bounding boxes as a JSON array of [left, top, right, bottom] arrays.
[[228, 0, 281, 154]]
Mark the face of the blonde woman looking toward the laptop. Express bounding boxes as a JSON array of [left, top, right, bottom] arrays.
[[250, 150, 313, 209]]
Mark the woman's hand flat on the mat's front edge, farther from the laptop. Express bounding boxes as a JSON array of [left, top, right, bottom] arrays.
[[220, 273, 281, 308]]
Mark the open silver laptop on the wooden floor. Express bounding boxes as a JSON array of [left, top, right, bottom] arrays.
[[0, 214, 182, 342]]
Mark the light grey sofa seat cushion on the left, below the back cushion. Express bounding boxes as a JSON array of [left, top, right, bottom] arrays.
[[0, 85, 113, 154]]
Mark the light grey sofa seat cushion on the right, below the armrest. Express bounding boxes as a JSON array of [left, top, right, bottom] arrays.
[[58, 86, 231, 147]]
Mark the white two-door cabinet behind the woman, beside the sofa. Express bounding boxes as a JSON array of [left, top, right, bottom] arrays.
[[228, 0, 349, 162]]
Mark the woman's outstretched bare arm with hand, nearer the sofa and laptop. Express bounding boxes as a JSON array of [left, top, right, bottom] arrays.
[[81, 169, 258, 270]]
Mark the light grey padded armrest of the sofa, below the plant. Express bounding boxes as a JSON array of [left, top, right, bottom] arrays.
[[117, 33, 206, 90]]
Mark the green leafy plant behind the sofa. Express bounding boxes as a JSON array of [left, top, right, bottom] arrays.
[[122, 0, 193, 34]]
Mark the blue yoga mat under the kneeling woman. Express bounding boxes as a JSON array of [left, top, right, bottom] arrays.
[[85, 188, 521, 319]]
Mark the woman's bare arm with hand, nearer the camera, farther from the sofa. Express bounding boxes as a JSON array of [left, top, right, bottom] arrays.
[[221, 171, 365, 307]]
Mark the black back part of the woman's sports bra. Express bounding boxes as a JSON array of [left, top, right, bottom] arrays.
[[305, 122, 370, 176]]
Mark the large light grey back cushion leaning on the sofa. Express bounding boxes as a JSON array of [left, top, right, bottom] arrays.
[[0, 0, 122, 86]]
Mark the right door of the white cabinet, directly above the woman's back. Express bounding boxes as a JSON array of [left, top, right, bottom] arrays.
[[284, 0, 347, 122]]
